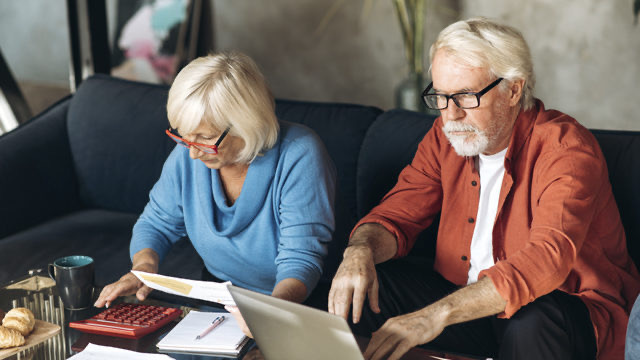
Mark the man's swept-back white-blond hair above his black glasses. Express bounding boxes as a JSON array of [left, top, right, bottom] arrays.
[[429, 17, 536, 110]]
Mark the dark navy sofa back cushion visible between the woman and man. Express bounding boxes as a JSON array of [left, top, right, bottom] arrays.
[[276, 100, 382, 280]]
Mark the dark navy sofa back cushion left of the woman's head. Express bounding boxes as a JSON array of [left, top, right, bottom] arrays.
[[67, 75, 175, 214]]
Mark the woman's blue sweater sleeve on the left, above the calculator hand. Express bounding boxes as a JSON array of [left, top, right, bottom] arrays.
[[129, 147, 186, 261]]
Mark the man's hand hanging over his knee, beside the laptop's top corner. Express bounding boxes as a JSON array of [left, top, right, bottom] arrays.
[[329, 244, 380, 324]]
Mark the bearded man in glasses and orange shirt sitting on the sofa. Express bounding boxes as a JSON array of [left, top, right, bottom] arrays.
[[329, 18, 640, 360]]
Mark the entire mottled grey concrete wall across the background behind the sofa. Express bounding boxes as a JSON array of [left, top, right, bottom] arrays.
[[0, 0, 640, 130]]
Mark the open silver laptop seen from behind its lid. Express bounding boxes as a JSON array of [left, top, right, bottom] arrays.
[[228, 285, 364, 360]]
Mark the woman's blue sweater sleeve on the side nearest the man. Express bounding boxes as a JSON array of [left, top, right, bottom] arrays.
[[275, 134, 336, 296]]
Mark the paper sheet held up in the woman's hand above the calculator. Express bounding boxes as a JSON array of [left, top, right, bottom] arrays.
[[131, 270, 236, 305]]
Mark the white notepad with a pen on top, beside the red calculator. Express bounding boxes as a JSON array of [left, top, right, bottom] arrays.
[[157, 310, 249, 357]]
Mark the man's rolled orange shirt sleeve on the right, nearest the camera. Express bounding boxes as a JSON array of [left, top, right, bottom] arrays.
[[478, 140, 608, 317]]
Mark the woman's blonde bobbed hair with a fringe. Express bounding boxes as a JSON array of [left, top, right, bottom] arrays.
[[167, 52, 279, 163]]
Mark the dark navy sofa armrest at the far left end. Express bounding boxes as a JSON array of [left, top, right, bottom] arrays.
[[0, 97, 80, 238]]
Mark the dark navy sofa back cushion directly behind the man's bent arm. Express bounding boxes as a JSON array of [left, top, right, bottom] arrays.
[[357, 109, 439, 258]]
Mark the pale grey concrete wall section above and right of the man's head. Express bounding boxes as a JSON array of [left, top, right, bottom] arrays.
[[461, 0, 640, 130]]
